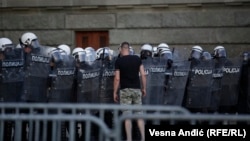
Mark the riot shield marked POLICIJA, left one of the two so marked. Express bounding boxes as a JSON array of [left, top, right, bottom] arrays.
[[185, 60, 214, 109]]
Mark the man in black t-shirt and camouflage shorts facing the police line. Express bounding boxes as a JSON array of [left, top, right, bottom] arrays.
[[113, 42, 146, 141]]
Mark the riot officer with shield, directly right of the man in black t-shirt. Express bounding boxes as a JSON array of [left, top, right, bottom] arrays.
[[140, 44, 167, 105]]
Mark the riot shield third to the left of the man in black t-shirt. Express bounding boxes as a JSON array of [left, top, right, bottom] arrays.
[[48, 55, 75, 103]]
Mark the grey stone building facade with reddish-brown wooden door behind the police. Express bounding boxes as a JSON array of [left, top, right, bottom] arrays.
[[0, 0, 250, 57]]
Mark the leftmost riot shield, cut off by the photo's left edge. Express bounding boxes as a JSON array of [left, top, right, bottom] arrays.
[[0, 49, 24, 102]]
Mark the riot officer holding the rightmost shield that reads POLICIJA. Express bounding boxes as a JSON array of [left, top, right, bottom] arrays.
[[214, 46, 242, 113]]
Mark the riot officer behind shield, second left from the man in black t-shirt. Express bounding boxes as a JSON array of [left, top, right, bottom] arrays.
[[76, 47, 101, 138]]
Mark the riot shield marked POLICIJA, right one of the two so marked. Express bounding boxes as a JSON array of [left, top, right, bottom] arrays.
[[220, 58, 242, 106]]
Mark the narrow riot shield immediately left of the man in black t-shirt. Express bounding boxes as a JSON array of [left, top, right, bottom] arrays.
[[99, 60, 115, 104]]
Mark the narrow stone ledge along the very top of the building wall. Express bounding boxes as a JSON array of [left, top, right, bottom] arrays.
[[1, 0, 249, 7]]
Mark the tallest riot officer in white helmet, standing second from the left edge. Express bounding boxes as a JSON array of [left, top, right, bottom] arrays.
[[20, 32, 50, 140]]
